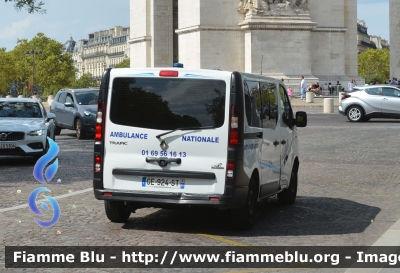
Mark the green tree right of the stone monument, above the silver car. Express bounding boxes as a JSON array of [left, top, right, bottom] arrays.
[[358, 49, 390, 83]]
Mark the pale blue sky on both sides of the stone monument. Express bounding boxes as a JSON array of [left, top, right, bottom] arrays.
[[0, 0, 390, 50]]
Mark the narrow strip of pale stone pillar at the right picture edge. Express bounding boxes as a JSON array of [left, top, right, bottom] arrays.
[[389, 0, 400, 79]]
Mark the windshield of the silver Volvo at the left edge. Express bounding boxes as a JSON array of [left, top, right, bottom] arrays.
[[0, 101, 43, 118]]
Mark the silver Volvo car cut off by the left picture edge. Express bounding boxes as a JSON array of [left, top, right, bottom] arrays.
[[0, 98, 55, 159]]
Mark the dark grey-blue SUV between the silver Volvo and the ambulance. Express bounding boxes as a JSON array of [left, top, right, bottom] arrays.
[[50, 88, 99, 139]]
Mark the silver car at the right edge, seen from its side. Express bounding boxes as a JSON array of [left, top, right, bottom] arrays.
[[339, 84, 400, 122]]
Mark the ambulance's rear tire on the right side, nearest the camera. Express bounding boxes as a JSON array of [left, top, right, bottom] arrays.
[[232, 175, 257, 230]]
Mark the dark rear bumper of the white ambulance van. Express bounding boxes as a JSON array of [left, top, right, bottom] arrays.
[[93, 180, 248, 209]]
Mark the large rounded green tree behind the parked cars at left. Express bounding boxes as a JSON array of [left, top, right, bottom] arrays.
[[10, 33, 75, 95]]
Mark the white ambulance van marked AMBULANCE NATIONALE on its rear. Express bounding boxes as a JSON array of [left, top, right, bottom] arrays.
[[93, 67, 307, 229]]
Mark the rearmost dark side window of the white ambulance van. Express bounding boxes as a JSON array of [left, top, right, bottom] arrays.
[[244, 81, 261, 127]]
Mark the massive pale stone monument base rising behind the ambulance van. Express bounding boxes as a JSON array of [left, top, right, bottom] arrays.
[[129, 0, 363, 85]]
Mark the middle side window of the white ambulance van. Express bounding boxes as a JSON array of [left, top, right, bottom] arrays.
[[261, 83, 278, 128]]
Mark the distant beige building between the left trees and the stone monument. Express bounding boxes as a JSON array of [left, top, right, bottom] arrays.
[[63, 26, 130, 79]]
